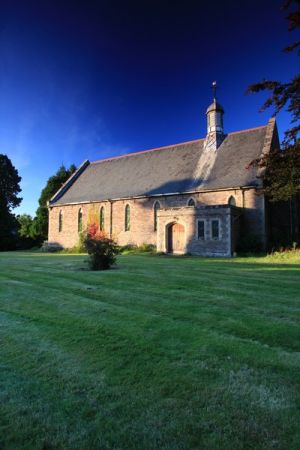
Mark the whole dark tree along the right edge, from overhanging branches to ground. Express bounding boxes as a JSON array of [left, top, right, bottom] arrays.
[[247, 0, 300, 247]]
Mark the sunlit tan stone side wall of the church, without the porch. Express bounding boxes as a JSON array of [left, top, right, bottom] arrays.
[[49, 185, 265, 252]]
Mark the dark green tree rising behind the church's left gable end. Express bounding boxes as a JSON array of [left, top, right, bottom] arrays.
[[32, 164, 76, 242]]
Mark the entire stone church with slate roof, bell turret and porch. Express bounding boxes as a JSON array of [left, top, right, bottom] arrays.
[[49, 99, 279, 256]]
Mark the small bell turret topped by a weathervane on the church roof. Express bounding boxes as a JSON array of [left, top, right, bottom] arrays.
[[204, 81, 225, 150]]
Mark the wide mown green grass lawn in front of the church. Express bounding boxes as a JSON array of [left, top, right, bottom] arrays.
[[0, 252, 300, 450]]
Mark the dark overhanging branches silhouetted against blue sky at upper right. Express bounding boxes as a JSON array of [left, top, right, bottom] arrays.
[[247, 0, 300, 145]]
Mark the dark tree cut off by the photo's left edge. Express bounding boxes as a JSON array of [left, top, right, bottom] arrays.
[[0, 154, 22, 250]]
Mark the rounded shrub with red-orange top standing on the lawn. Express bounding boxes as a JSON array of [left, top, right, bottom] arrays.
[[84, 225, 119, 270]]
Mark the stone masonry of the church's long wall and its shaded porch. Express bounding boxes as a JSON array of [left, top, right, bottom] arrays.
[[49, 185, 265, 255]]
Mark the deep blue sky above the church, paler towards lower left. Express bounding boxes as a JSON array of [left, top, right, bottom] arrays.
[[0, 0, 298, 215]]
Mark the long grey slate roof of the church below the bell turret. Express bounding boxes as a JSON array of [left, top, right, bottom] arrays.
[[50, 125, 268, 205]]
